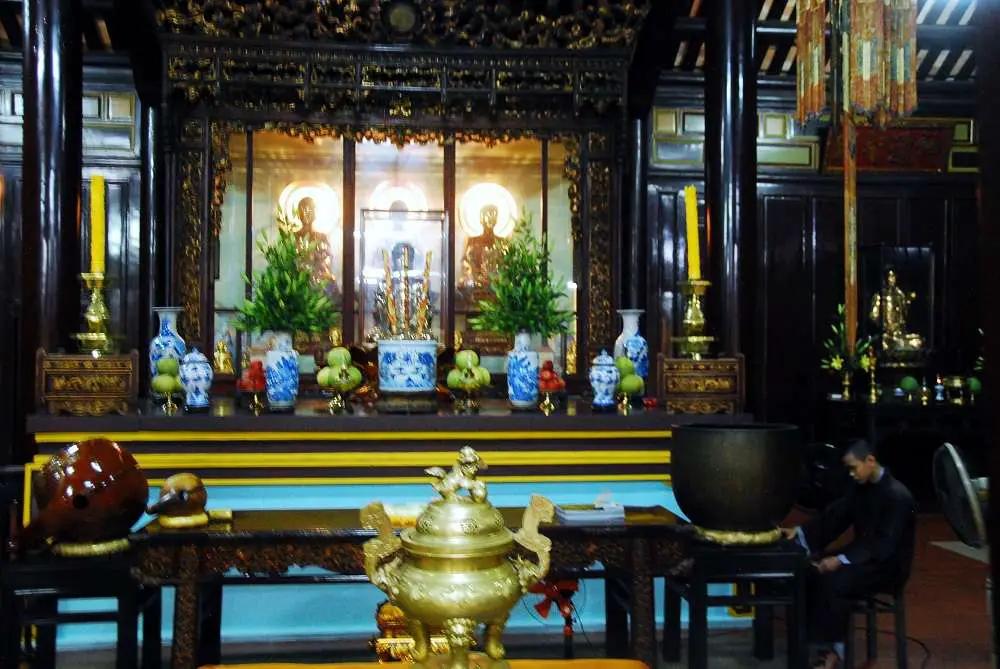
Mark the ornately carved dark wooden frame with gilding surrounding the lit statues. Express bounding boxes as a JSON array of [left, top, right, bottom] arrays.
[[123, 0, 649, 368]]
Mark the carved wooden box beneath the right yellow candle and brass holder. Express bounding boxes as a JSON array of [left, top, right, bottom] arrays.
[[657, 354, 746, 414]]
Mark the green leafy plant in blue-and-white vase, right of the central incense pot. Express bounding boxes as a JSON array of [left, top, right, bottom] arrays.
[[469, 212, 573, 408]]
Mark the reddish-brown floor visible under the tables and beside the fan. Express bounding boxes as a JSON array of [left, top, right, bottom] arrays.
[[50, 515, 990, 669]]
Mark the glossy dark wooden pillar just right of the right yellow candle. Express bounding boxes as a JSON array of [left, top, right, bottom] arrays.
[[705, 0, 757, 355]]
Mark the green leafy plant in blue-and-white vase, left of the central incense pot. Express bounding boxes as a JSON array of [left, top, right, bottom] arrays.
[[235, 213, 337, 411]]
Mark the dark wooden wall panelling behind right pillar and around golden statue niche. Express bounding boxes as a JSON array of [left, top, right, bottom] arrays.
[[647, 174, 979, 434]]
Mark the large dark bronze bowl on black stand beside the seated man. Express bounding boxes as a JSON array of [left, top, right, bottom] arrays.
[[670, 423, 802, 532]]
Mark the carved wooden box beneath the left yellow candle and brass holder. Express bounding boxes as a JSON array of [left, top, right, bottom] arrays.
[[35, 349, 139, 416]]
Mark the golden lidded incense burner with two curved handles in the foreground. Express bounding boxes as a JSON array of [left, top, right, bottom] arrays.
[[361, 446, 553, 669]]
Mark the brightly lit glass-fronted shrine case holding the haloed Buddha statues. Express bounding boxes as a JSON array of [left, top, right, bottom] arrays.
[[215, 129, 586, 374]]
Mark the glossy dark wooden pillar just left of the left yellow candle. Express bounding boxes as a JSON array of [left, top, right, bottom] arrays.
[[18, 0, 83, 444]]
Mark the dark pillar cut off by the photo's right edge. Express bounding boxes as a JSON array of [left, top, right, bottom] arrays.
[[976, 2, 1000, 669]]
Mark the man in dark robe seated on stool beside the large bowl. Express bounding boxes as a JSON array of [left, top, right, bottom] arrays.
[[782, 441, 916, 669]]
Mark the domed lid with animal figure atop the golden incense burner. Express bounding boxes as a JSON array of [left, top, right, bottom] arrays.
[[400, 446, 513, 559]]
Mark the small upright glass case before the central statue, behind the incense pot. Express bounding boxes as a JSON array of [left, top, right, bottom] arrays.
[[358, 209, 449, 346]]
